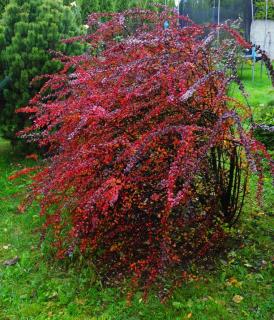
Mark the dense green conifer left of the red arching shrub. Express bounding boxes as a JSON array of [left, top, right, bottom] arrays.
[[0, 0, 81, 140]]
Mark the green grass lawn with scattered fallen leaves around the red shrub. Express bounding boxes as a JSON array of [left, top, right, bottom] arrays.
[[0, 68, 274, 320]]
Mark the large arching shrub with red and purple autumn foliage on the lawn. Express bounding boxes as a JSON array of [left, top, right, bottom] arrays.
[[18, 10, 272, 291]]
